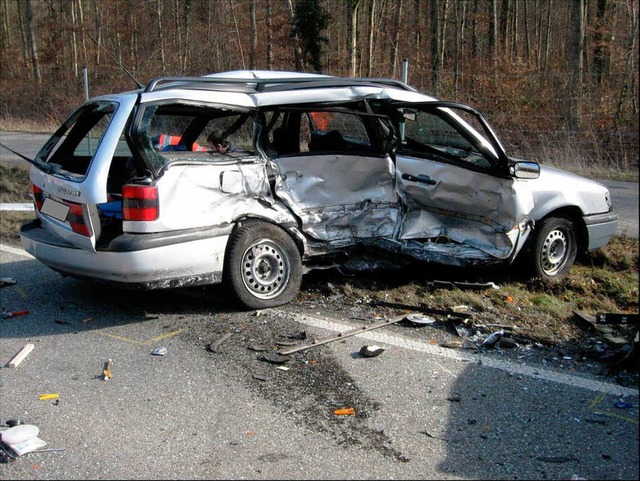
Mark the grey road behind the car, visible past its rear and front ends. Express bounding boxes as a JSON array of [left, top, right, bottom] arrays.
[[0, 132, 640, 239]]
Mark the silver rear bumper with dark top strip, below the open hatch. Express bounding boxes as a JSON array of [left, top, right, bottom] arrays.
[[20, 221, 230, 289]]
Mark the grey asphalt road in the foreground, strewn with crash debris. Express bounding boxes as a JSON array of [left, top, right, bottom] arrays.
[[0, 246, 639, 479]]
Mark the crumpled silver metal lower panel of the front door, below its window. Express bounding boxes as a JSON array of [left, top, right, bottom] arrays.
[[397, 156, 533, 259]]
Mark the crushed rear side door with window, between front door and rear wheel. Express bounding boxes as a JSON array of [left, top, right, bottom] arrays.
[[268, 109, 398, 244]]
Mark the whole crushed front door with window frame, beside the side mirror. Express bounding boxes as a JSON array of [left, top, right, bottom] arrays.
[[396, 102, 533, 258]]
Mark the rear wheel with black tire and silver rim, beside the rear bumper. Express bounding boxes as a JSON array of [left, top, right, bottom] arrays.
[[224, 222, 302, 309]]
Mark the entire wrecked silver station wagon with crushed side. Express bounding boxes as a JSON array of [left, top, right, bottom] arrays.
[[20, 71, 617, 309]]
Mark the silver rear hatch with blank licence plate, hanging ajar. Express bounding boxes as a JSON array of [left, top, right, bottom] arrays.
[[30, 93, 137, 251]]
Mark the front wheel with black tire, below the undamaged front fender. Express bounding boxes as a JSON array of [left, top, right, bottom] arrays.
[[528, 217, 578, 281]]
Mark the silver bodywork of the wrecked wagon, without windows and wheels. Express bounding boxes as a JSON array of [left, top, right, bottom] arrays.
[[21, 71, 617, 296]]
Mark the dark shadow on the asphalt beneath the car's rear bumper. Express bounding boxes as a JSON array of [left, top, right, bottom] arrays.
[[0, 259, 238, 338]]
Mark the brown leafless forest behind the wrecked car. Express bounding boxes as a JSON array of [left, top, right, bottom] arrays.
[[0, 0, 639, 180]]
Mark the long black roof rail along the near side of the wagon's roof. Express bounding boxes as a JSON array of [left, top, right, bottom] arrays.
[[144, 77, 416, 92]]
